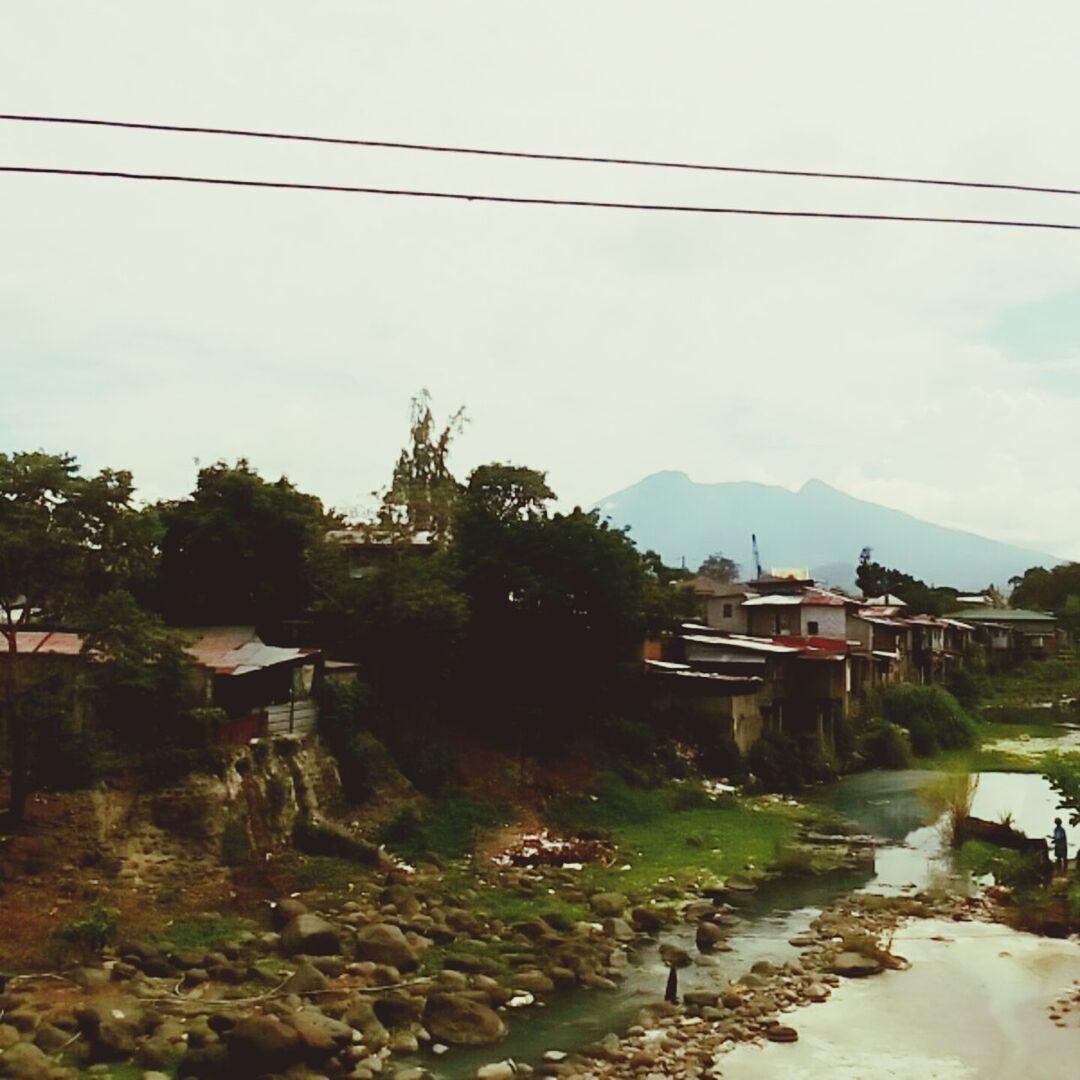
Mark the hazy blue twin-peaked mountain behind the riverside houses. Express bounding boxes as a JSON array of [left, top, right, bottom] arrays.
[[596, 472, 1063, 590]]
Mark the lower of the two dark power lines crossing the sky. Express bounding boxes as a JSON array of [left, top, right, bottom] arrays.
[[0, 165, 1080, 231]]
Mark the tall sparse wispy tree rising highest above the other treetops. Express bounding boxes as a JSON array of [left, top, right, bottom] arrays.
[[377, 390, 465, 543]]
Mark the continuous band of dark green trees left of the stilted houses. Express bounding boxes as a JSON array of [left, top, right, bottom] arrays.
[[0, 394, 691, 819]]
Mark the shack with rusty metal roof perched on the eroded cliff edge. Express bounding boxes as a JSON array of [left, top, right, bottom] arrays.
[[186, 626, 323, 742]]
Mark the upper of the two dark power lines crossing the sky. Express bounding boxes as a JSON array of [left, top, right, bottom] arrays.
[[0, 113, 1080, 195]]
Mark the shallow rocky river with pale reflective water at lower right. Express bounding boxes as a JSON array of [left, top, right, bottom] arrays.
[[414, 770, 1080, 1080]]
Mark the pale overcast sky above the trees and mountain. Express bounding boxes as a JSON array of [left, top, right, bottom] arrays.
[[0, 6, 1080, 558]]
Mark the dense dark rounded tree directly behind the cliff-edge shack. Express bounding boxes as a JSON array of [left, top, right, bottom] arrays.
[[159, 459, 328, 625]]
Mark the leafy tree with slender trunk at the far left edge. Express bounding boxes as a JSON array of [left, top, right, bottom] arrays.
[[0, 451, 154, 824]]
